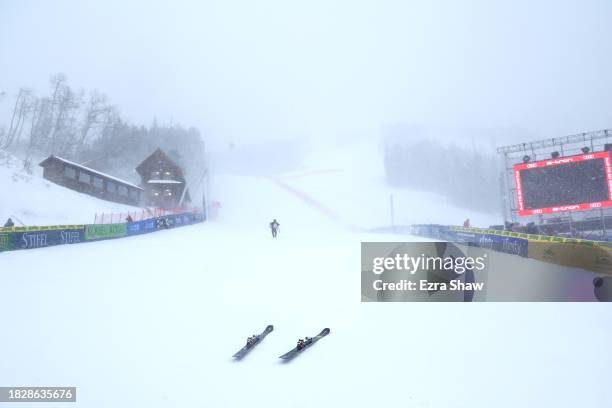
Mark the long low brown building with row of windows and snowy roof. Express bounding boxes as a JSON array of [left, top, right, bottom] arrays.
[[40, 155, 144, 206]]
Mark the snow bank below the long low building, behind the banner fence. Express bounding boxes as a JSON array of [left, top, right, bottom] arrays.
[[0, 151, 142, 226]]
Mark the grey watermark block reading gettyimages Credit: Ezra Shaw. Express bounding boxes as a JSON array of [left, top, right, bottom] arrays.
[[361, 242, 488, 302]]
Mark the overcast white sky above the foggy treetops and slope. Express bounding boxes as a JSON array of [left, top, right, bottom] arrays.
[[0, 0, 612, 147]]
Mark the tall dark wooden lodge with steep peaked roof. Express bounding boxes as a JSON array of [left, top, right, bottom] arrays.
[[136, 149, 191, 208]]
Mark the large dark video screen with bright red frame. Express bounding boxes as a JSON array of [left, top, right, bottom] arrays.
[[513, 151, 612, 216]]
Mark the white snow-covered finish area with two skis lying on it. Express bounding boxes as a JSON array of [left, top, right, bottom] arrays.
[[0, 145, 612, 408]]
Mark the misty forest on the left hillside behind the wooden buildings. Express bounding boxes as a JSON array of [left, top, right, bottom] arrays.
[[0, 73, 205, 181]]
